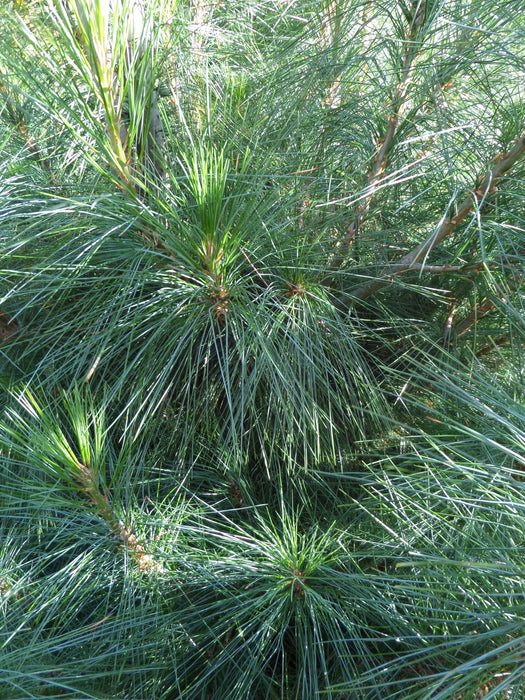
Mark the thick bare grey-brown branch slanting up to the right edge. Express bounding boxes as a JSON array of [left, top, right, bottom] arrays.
[[338, 134, 525, 307]]
